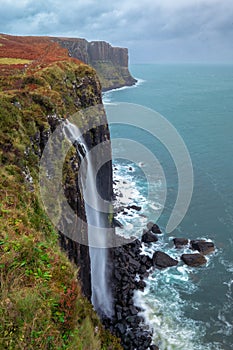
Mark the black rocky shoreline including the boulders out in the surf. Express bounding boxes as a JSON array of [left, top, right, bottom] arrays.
[[103, 215, 215, 350]]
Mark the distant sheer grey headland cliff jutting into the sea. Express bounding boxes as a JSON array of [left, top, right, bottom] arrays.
[[52, 38, 136, 91]]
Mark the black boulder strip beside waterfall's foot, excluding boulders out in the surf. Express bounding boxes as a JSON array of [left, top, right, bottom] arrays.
[[109, 239, 155, 350]]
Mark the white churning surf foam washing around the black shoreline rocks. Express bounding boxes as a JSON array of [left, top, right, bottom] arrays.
[[113, 161, 220, 350]]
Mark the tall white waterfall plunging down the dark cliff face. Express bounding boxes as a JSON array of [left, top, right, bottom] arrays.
[[64, 121, 112, 318]]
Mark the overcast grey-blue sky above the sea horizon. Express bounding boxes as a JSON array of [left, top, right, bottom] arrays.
[[0, 0, 233, 63]]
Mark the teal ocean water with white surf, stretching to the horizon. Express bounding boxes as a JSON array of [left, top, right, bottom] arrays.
[[104, 64, 233, 350]]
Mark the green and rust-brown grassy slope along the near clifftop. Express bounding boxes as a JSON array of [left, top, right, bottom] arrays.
[[0, 36, 121, 350]]
